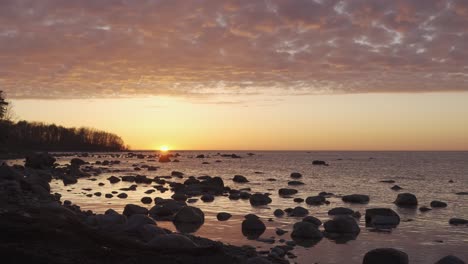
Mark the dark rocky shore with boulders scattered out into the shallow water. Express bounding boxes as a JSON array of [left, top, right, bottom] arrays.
[[0, 153, 467, 264]]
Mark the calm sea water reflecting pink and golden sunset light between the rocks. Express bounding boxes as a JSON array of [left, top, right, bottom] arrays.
[[22, 151, 468, 263]]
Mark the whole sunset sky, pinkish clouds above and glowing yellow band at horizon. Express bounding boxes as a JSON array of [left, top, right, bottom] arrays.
[[0, 0, 468, 150]]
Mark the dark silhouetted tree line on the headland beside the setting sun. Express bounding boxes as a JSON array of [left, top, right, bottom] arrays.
[[0, 91, 127, 152]]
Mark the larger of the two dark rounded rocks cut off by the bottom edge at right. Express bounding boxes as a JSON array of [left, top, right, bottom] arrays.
[[362, 248, 409, 264]]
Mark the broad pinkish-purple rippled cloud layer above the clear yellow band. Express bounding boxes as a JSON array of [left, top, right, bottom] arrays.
[[0, 0, 468, 99]]
